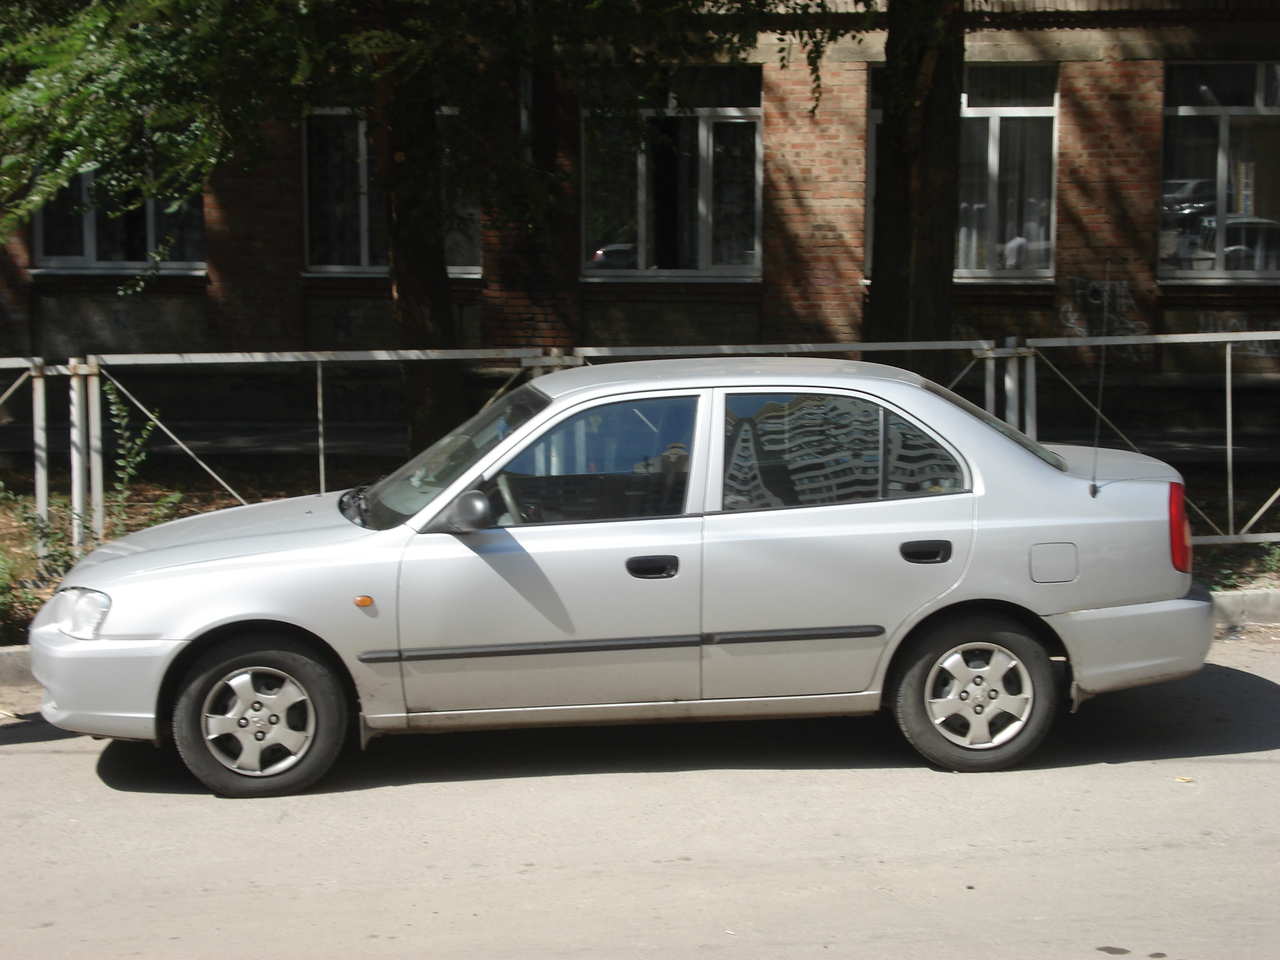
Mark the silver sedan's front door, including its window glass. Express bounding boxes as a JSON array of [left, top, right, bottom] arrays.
[[399, 390, 709, 712]]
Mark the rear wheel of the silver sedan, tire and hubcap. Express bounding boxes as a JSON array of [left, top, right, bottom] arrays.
[[891, 616, 1061, 773]]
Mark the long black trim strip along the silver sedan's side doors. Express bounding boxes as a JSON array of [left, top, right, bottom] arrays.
[[357, 625, 884, 663]]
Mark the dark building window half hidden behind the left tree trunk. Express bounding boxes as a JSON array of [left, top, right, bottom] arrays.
[[306, 108, 480, 276]]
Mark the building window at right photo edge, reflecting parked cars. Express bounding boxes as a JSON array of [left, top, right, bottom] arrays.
[[1160, 63, 1280, 279]]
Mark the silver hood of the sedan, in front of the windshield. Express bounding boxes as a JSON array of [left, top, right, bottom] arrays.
[[65, 493, 374, 585]]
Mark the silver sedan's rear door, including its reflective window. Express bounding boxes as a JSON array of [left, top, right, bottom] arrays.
[[703, 389, 974, 699]]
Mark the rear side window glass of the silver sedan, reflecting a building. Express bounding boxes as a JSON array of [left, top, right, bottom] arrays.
[[723, 393, 964, 511]]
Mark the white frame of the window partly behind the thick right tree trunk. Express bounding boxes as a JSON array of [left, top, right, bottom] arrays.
[[865, 61, 1059, 283]]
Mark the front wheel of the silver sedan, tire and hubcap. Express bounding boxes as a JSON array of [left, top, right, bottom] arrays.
[[173, 637, 351, 797]]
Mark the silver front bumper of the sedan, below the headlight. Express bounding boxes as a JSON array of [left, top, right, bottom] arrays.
[[29, 623, 186, 740]]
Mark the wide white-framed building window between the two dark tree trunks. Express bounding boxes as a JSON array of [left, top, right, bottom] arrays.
[[582, 67, 764, 279]]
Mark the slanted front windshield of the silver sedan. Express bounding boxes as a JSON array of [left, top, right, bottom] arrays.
[[356, 384, 550, 530]]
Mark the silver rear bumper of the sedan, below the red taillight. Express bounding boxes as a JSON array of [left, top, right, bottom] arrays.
[[1046, 585, 1213, 699]]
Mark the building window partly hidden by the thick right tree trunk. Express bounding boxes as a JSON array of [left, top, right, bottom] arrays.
[[868, 65, 1057, 279]]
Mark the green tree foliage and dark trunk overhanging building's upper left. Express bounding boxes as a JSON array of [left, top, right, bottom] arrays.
[[0, 0, 863, 332]]
